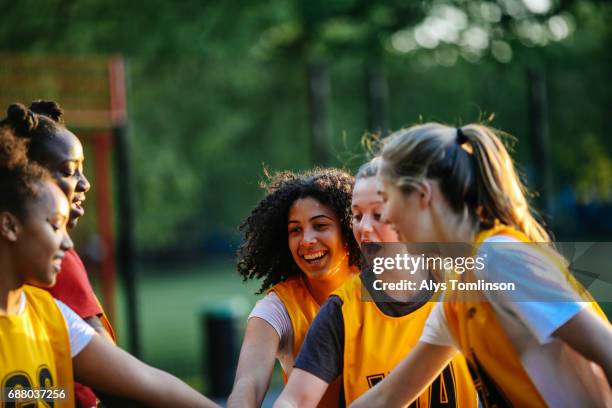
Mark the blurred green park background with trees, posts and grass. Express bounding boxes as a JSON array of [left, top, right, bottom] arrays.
[[0, 0, 612, 404]]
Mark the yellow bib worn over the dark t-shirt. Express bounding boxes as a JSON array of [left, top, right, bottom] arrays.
[[334, 276, 477, 408]]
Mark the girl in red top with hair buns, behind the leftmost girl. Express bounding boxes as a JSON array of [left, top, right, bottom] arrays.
[[0, 100, 116, 407]]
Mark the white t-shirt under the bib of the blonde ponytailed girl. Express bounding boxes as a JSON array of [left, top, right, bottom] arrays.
[[420, 236, 612, 408]]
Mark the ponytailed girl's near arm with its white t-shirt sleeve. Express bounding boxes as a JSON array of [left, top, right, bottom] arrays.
[[487, 244, 612, 384]]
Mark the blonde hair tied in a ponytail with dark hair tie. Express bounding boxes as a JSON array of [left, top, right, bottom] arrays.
[[380, 123, 550, 242]]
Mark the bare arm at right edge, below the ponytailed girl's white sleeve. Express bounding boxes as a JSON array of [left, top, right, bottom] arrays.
[[553, 308, 612, 385]]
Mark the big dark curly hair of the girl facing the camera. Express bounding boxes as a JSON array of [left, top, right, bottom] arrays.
[[237, 168, 360, 293]]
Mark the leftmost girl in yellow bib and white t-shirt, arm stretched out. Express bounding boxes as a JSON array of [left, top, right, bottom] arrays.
[[0, 127, 216, 408]]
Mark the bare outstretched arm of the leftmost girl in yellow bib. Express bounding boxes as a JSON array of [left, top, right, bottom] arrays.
[[72, 336, 217, 407]]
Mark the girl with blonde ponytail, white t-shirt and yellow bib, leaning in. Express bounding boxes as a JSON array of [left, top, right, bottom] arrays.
[[352, 123, 612, 407]]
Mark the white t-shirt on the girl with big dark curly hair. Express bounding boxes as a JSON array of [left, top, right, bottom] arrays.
[[249, 292, 295, 375]]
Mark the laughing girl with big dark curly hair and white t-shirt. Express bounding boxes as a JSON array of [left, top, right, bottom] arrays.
[[228, 169, 360, 407]]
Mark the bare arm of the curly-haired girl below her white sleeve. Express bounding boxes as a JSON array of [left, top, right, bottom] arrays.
[[227, 317, 280, 407]]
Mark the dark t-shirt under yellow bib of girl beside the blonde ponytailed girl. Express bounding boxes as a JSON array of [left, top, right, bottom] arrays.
[[295, 275, 431, 384]]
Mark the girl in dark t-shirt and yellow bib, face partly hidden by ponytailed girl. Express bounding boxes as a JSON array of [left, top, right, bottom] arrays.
[[275, 158, 477, 408]]
